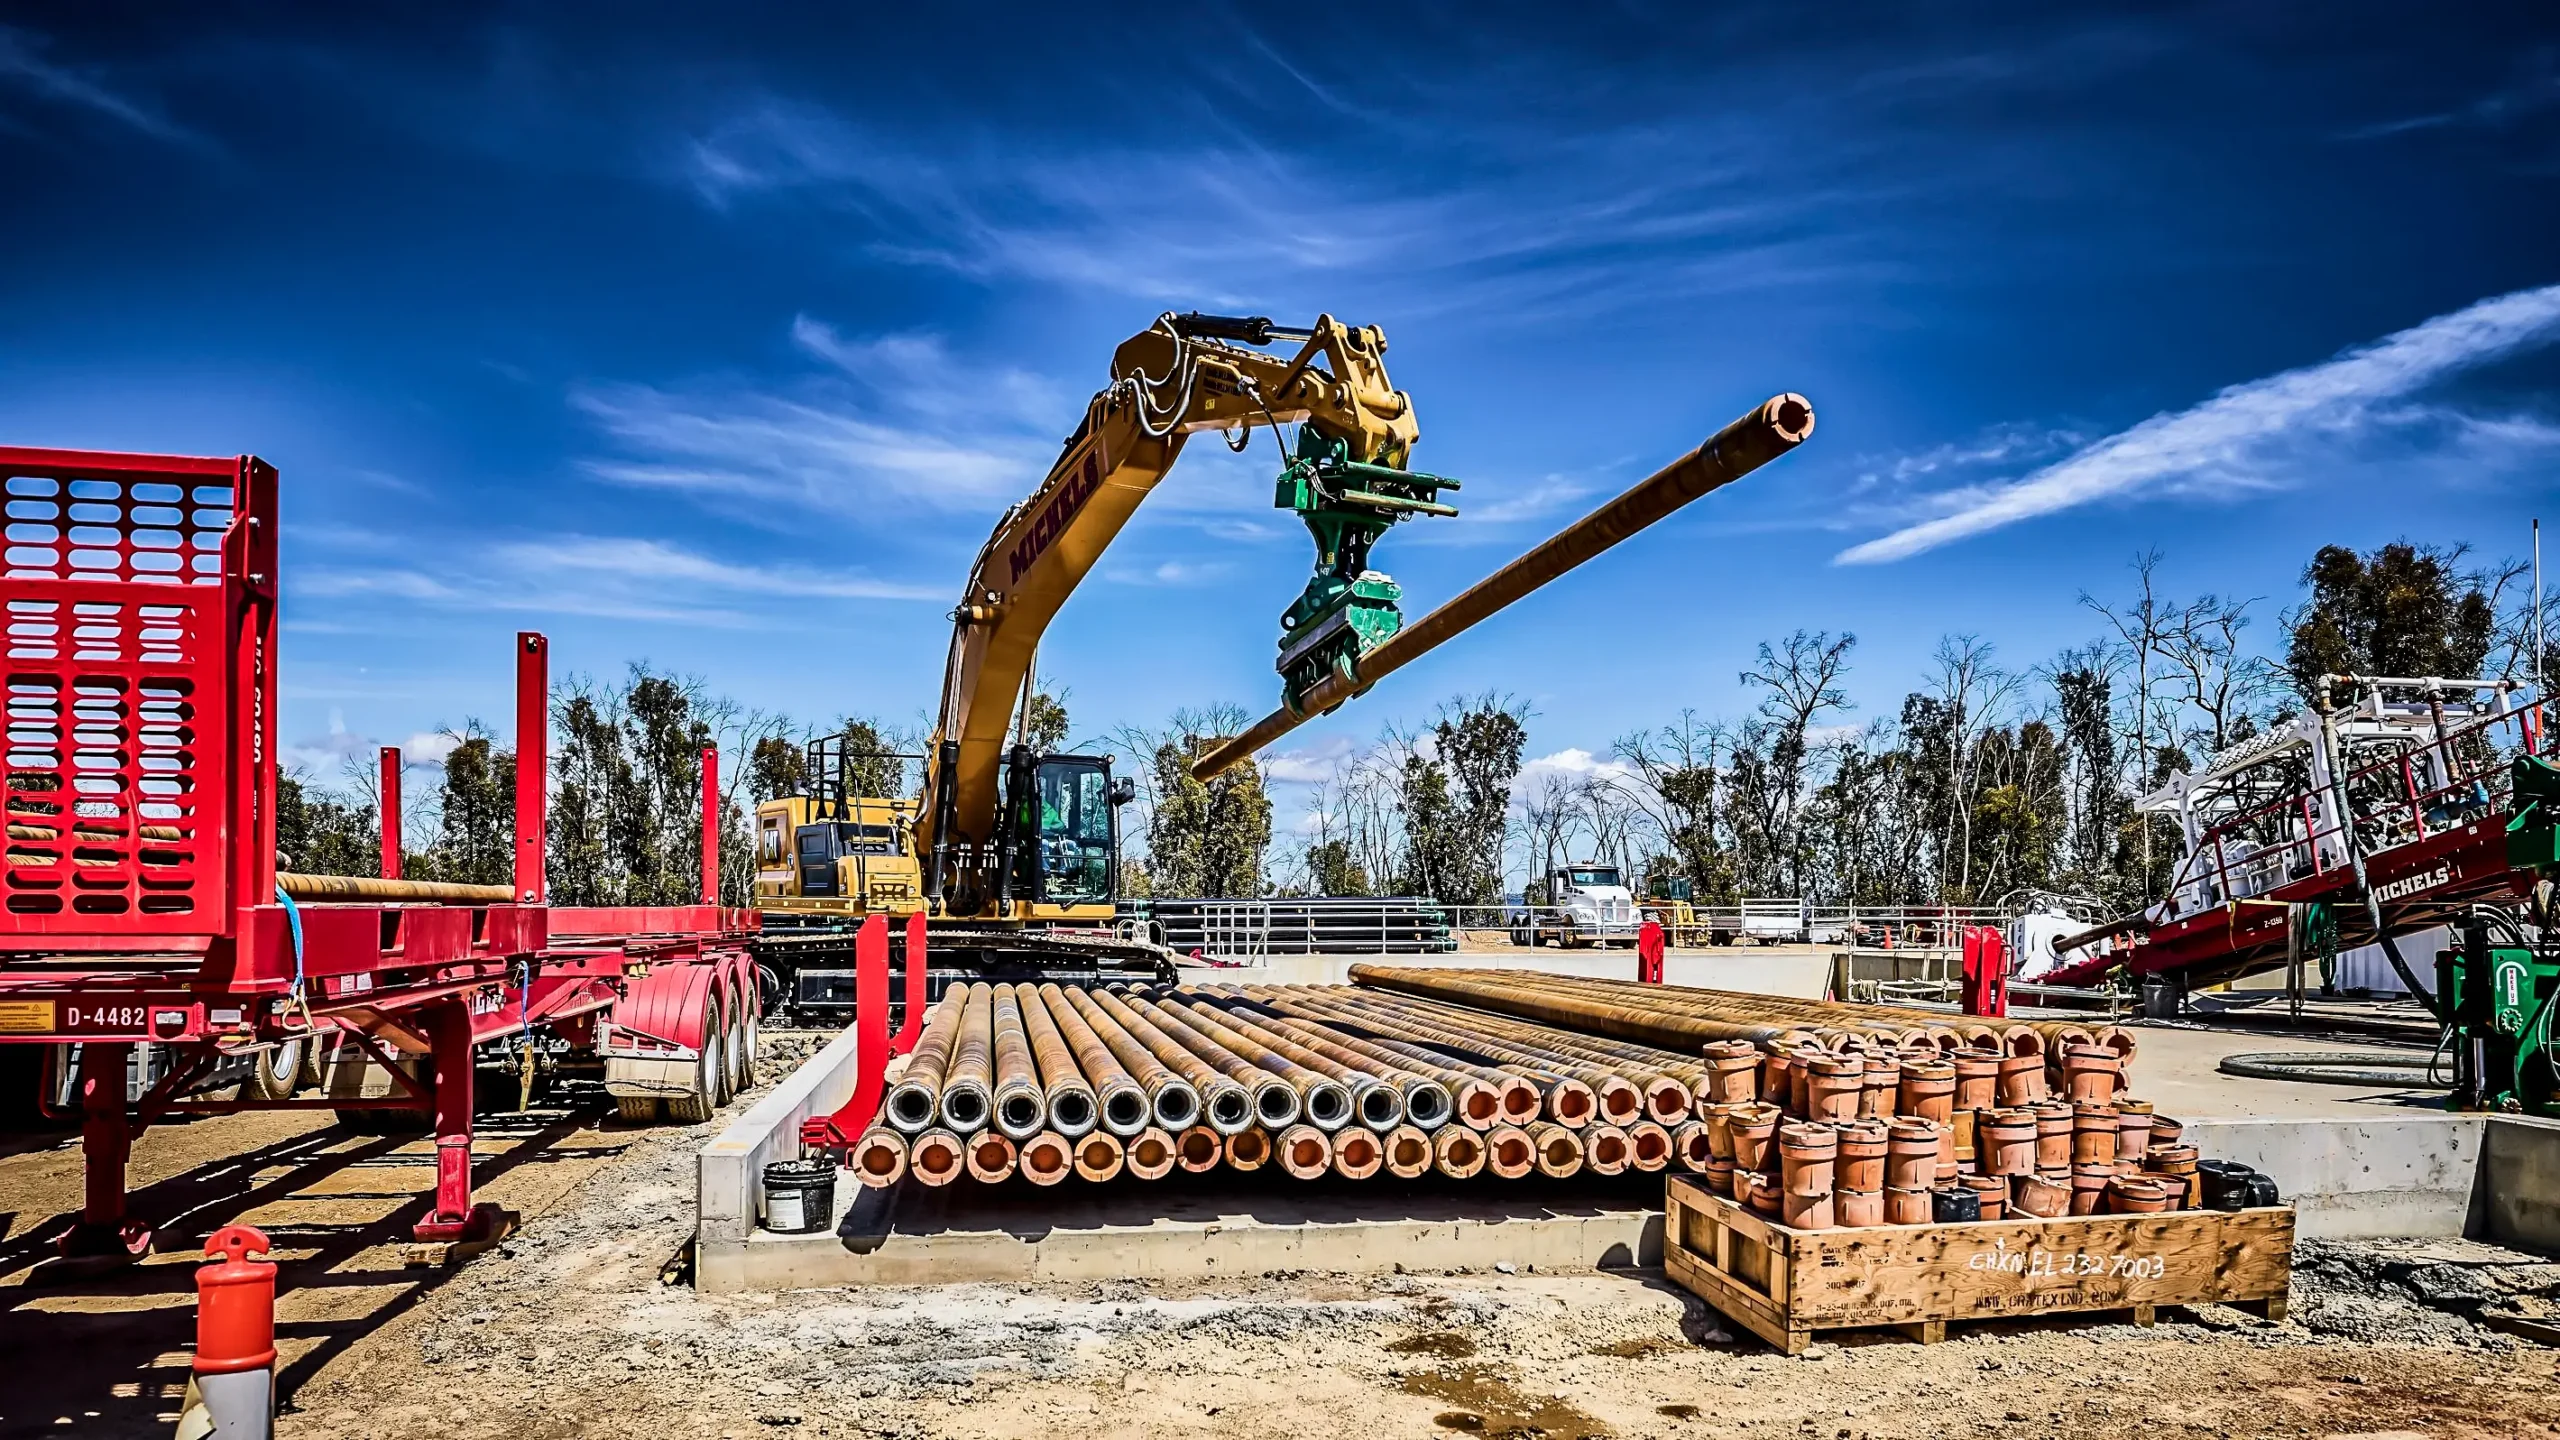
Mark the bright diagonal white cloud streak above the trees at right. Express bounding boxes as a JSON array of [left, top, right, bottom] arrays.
[[1833, 284, 2560, 564]]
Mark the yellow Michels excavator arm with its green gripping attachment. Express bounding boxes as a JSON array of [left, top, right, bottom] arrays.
[[916, 315, 1454, 917]]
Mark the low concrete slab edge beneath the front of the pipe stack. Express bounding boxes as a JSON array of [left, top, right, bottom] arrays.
[[694, 1171, 1661, 1291]]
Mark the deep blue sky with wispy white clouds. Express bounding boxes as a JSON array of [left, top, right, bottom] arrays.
[[0, 5, 2560, 794]]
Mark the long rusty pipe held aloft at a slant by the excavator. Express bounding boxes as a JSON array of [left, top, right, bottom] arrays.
[[1190, 392, 1812, 779]]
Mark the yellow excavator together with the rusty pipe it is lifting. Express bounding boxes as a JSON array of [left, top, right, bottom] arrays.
[[755, 313, 1812, 1010]]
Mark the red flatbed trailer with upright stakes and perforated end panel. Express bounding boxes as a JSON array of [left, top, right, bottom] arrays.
[[0, 446, 760, 1256]]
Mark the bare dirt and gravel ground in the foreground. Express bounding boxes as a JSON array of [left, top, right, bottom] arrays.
[[0, 1030, 2560, 1440]]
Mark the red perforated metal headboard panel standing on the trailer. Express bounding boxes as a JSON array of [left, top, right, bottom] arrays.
[[0, 448, 274, 945]]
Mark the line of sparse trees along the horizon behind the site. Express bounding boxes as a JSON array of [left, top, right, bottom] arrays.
[[276, 543, 2560, 907]]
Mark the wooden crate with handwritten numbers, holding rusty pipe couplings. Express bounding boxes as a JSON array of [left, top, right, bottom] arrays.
[[1661, 1176, 2294, 1355]]
